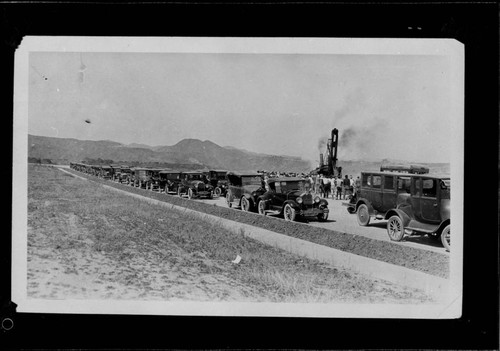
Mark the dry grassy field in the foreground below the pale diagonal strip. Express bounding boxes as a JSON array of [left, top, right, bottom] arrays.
[[28, 166, 436, 304]]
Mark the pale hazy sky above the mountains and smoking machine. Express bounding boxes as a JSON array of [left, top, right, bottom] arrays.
[[28, 52, 459, 162]]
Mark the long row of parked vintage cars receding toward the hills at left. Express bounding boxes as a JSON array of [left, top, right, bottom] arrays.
[[70, 163, 329, 221]]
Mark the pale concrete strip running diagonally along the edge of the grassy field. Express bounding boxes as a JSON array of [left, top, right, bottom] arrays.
[[61, 169, 450, 300]]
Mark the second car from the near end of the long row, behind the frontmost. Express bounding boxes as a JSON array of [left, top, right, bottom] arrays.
[[226, 172, 266, 212]]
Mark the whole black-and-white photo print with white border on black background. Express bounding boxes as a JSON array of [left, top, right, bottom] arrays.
[[12, 37, 464, 319]]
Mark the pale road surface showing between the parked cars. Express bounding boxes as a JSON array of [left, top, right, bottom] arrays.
[[193, 194, 449, 255]]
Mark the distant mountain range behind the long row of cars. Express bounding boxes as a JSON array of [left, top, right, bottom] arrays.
[[28, 135, 312, 172]]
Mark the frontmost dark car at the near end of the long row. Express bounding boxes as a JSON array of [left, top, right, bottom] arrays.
[[258, 177, 329, 221]]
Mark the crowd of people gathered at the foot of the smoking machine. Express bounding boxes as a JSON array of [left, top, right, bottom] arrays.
[[258, 171, 361, 200]]
